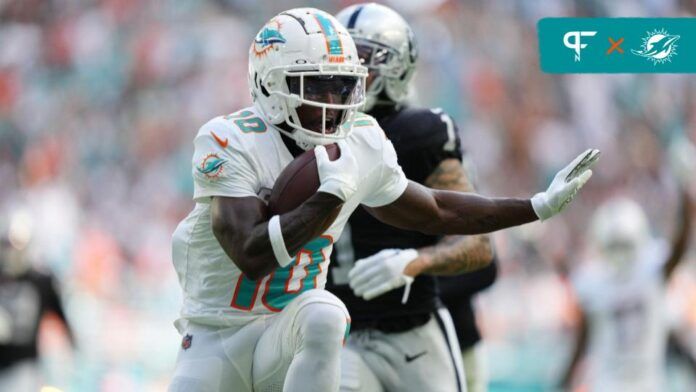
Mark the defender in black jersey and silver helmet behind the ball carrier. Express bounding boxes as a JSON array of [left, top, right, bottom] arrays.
[[327, 3, 495, 391]]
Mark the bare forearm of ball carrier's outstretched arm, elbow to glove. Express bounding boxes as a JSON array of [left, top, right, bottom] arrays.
[[422, 190, 539, 234]]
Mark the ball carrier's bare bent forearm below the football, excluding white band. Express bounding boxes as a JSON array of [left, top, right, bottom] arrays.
[[243, 192, 342, 280]]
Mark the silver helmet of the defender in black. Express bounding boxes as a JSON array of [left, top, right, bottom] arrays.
[[336, 3, 418, 111]]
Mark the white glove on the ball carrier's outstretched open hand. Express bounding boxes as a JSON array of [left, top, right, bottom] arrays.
[[532, 149, 599, 220]]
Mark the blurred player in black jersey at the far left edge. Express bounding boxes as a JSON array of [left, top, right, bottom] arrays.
[[0, 211, 73, 391]]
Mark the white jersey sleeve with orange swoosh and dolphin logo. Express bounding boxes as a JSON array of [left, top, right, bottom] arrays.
[[192, 120, 259, 203]]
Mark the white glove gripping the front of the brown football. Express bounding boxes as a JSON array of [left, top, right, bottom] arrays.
[[314, 140, 358, 202]]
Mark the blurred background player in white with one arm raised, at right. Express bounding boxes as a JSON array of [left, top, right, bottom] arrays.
[[561, 142, 696, 392]]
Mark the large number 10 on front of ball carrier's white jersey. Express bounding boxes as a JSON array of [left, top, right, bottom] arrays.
[[230, 237, 332, 312]]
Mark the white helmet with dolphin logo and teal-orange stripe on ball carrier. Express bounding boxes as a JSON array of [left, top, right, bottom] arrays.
[[249, 8, 367, 149]]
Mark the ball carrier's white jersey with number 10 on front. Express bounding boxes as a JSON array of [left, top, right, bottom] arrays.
[[172, 107, 408, 330]]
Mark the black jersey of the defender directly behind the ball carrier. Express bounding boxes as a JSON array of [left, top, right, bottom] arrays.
[[326, 107, 462, 331]]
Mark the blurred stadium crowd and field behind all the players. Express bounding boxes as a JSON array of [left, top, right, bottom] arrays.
[[0, 0, 696, 391]]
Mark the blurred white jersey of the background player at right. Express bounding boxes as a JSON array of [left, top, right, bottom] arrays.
[[572, 241, 668, 391]]
